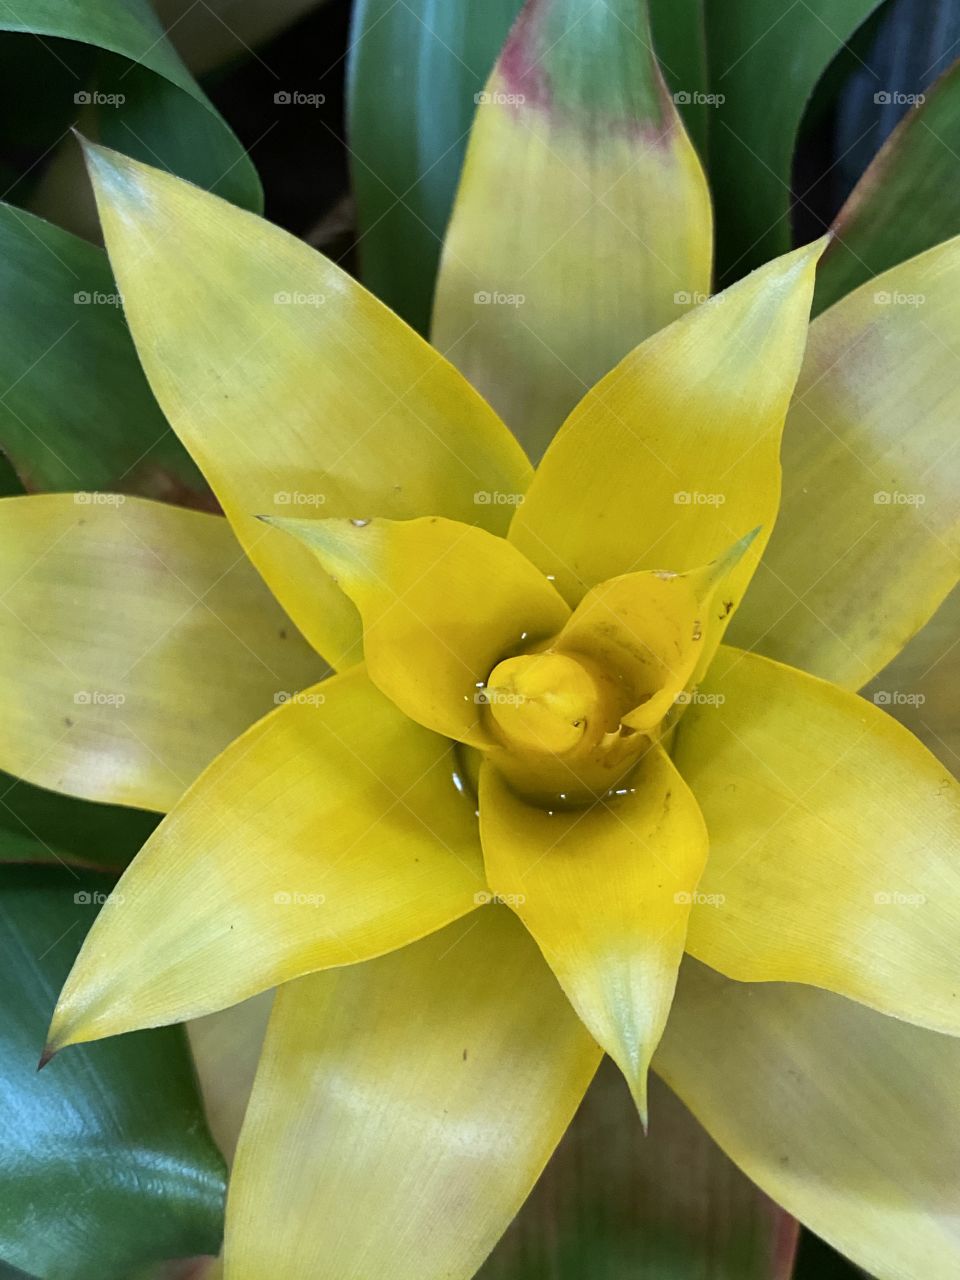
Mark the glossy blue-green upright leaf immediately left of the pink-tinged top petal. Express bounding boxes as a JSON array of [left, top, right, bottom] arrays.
[[348, 0, 522, 333]]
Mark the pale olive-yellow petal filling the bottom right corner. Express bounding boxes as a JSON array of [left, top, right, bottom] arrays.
[[654, 960, 960, 1280]]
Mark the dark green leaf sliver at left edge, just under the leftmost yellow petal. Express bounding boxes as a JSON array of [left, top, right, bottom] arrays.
[[0, 773, 160, 872]]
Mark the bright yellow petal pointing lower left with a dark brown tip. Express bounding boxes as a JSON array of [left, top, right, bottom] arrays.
[[50, 668, 484, 1050]]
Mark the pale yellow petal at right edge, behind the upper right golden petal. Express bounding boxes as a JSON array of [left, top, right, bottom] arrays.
[[731, 238, 960, 689]]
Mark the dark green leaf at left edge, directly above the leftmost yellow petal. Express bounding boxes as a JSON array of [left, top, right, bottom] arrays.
[[0, 205, 212, 506]]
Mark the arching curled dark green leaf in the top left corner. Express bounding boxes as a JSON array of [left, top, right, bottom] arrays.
[[0, 0, 262, 211]]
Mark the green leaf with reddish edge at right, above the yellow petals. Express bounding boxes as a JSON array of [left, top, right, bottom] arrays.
[[814, 61, 960, 311]]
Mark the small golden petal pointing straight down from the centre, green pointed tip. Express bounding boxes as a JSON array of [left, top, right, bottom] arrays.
[[480, 748, 707, 1123]]
